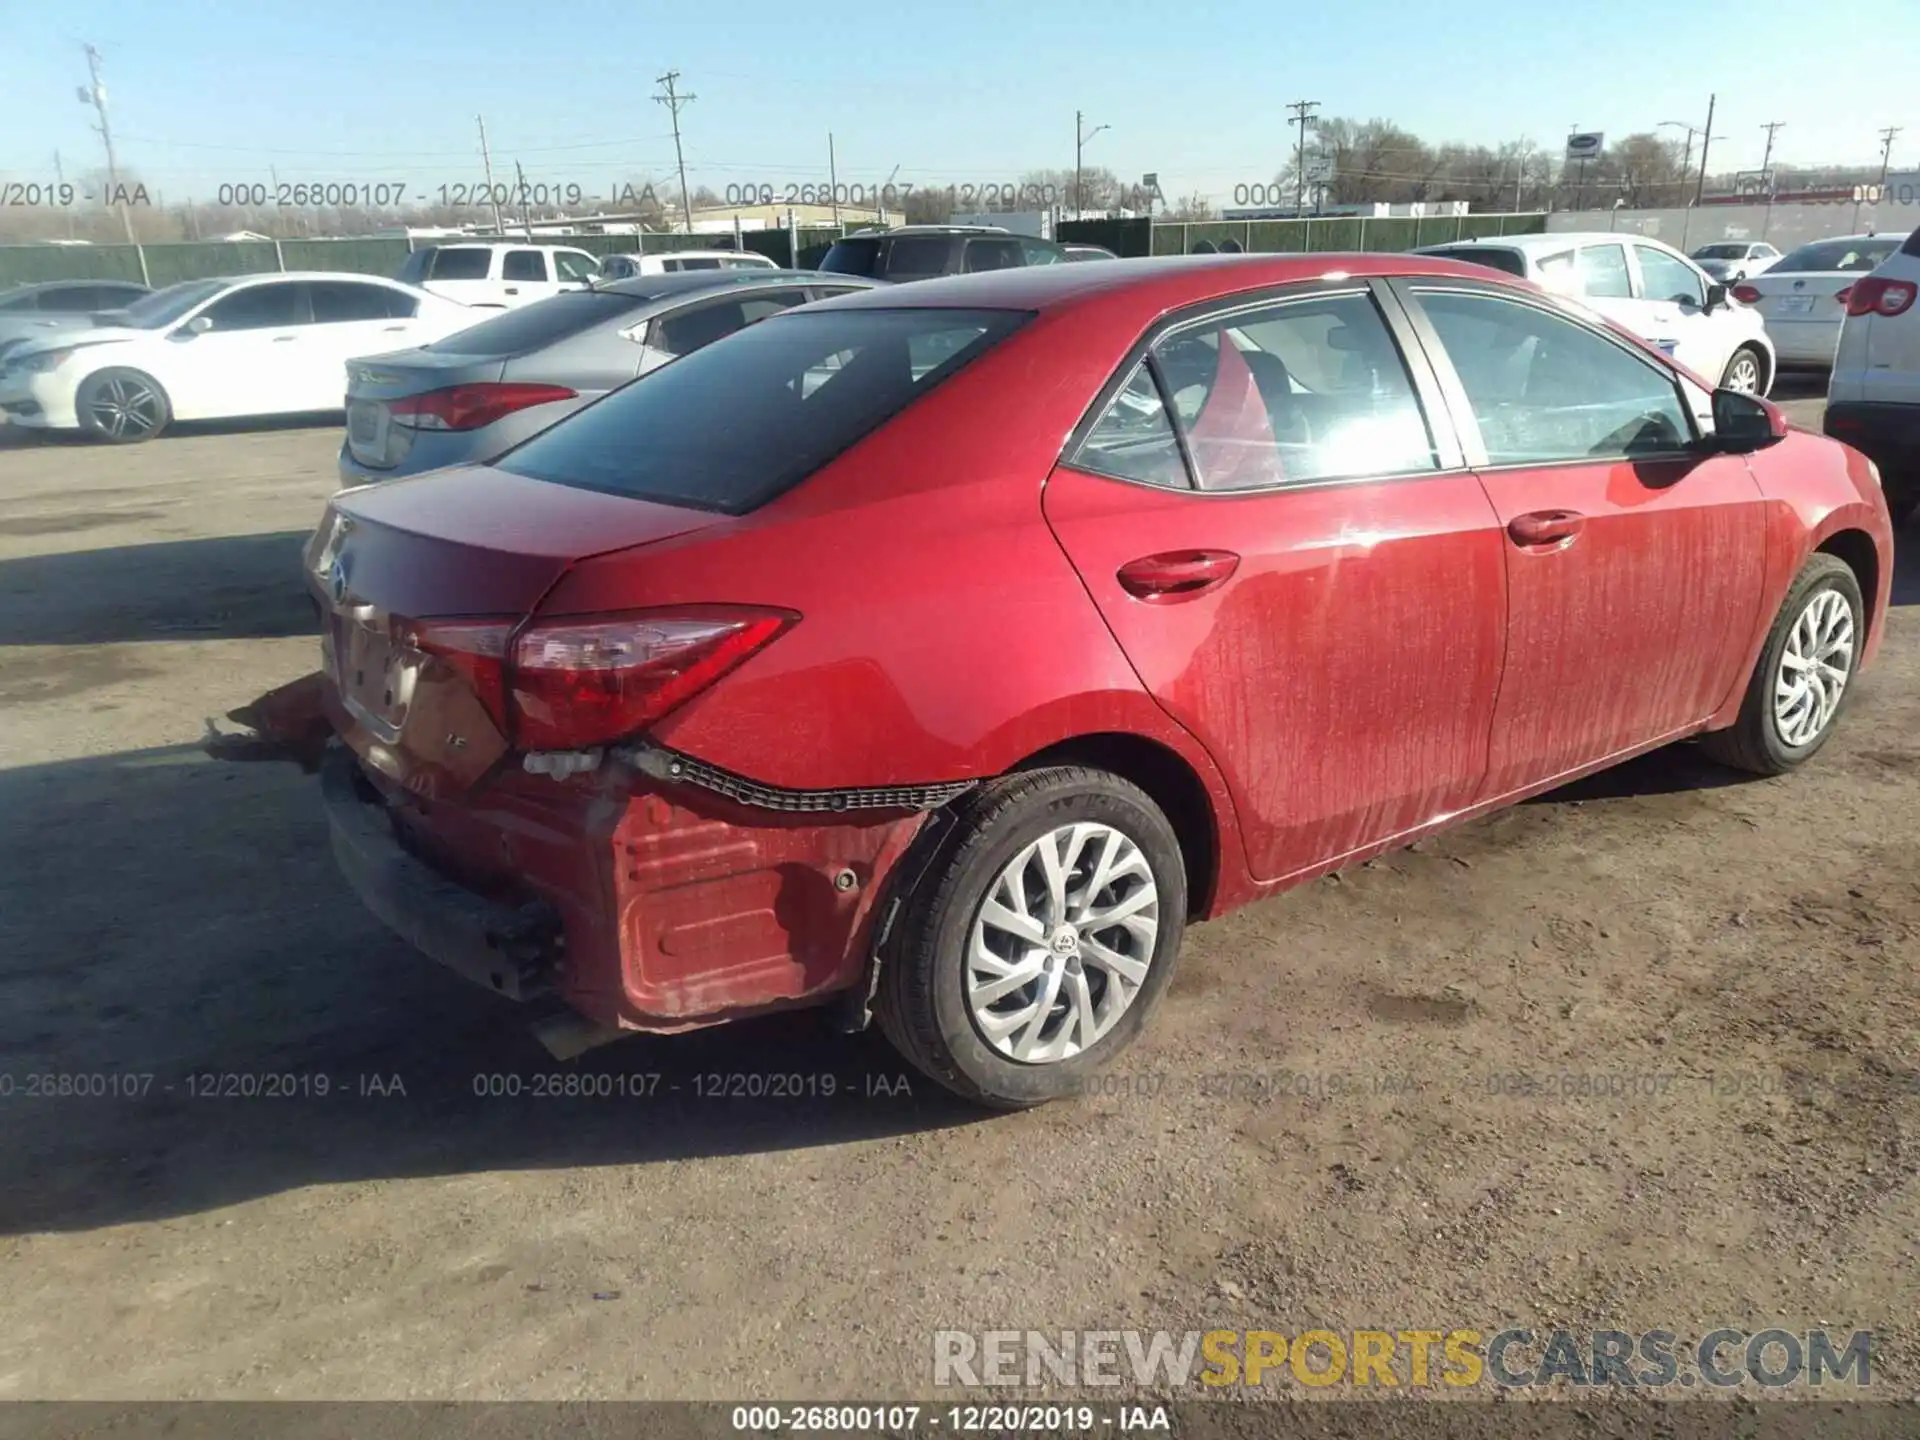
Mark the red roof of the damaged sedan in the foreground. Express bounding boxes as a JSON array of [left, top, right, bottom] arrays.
[[808, 252, 1534, 319]]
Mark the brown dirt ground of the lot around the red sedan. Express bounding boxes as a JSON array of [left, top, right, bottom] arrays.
[[0, 389, 1920, 1400]]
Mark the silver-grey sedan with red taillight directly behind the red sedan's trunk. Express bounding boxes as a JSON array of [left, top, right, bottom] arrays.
[[340, 269, 877, 486]]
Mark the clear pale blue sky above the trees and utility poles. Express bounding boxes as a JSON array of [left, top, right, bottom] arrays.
[[0, 0, 1920, 202]]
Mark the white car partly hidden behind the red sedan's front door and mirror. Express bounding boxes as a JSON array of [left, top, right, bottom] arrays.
[[1415, 230, 1778, 396]]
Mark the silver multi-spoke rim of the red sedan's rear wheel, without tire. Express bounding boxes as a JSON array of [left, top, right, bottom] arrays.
[[966, 822, 1160, 1064]]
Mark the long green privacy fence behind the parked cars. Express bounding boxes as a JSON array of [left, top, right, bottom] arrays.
[[0, 213, 1548, 288]]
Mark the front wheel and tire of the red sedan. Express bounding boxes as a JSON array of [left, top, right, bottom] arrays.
[[1701, 555, 1866, 776]]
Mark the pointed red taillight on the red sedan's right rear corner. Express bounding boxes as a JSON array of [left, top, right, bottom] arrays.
[[509, 605, 799, 751]]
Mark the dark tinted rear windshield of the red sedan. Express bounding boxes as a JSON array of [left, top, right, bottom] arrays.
[[499, 309, 1029, 515]]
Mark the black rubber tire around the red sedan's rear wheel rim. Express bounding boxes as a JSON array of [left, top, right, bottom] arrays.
[[876, 766, 1187, 1110]]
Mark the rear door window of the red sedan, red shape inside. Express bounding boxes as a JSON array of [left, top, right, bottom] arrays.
[[1152, 294, 1438, 490]]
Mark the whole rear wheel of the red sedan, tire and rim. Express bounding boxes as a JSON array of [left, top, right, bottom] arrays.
[[877, 766, 1187, 1110]]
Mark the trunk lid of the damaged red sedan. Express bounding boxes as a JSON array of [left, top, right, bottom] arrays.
[[307, 467, 726, 797]]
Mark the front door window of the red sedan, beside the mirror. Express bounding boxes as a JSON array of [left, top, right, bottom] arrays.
[[1415, 288, 1693, 465]]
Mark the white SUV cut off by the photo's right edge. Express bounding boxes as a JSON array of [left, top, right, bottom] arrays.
[[1824, 230, 1920, 524]]
